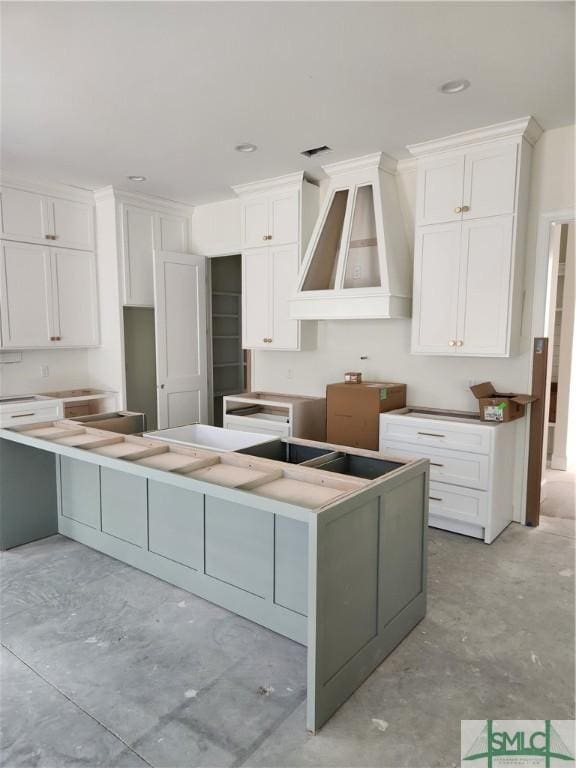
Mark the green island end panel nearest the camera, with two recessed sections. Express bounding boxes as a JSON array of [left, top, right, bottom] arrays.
[[306, 464, 428, 732]]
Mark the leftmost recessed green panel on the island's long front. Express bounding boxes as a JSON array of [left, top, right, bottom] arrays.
[[60, 456, 100, 530]]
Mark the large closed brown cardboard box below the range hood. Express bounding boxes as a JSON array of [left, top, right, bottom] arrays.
[[326, 381, 406, 451]]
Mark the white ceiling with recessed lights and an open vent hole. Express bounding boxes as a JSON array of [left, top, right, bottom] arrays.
[[2, 2, 574, 203]]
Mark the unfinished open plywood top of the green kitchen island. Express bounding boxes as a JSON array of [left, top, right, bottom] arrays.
[[2, 419, 424, 511]]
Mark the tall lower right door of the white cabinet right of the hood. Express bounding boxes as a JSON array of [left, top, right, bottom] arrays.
[[456, 216, 514, 356]]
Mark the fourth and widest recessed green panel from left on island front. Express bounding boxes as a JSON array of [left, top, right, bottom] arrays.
[[204, 496, 274, 599]]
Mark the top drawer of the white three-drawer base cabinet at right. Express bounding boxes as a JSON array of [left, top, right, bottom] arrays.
[[380, 414, 493, 453]]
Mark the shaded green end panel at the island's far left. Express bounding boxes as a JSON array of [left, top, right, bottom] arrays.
[[0, 440, 58, 550]]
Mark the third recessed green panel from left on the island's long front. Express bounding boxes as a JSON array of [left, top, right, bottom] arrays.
[[148, 480, 204, 571]]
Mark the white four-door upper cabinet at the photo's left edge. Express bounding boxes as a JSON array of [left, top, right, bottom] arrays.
[[0, 180, 99, 349]]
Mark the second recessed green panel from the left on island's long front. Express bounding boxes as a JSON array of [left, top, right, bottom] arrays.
[[101, 467, 148, 549]]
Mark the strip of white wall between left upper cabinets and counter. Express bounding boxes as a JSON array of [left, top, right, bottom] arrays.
[[0, 349, 89, 395]]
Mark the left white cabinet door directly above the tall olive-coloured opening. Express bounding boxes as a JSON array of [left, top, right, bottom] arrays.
[[122, 203, 156, 307]]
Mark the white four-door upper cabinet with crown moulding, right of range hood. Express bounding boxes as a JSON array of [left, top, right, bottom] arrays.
[[409, 118, 541, 357]]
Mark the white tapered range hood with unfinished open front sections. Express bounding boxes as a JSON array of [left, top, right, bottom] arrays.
[[290, 152, 412, 320]]
